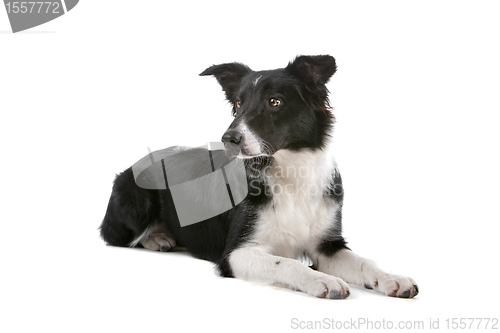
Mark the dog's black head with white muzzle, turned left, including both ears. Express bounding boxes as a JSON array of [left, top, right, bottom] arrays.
[[200, 55, 337, 157]]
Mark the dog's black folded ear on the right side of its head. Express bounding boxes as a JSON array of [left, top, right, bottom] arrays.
[[286, 55, 337, 91]]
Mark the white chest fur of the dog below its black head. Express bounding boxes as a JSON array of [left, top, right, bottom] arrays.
[[252, 150, 339, 258]]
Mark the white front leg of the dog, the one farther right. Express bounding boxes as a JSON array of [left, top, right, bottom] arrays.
[[317, 249, 418, 298]]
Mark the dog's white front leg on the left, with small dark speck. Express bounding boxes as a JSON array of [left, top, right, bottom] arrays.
[[229, 245, 349, 299]]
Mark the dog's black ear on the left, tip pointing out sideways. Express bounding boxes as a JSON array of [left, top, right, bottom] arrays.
[[200, 62, 252, 103]]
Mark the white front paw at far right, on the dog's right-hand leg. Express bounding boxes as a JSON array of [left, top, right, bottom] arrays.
[[372, 274, 418, 298]]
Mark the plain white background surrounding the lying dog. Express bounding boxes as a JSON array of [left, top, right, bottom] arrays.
[[0, 0, 500, 332]]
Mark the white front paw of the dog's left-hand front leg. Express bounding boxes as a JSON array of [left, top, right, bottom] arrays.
[[304, 273, 350, 299]]
